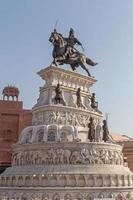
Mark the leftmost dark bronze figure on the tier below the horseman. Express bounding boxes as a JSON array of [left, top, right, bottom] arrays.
[[55, 83, 66, 106]]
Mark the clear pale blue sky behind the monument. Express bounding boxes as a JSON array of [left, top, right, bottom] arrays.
[[0, 0, 133, 136]]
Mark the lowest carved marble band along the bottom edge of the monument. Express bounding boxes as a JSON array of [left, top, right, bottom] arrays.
[[0, 192, 133, 200]]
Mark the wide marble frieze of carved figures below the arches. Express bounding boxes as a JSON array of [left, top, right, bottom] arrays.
[[12, 148, 123, 165]]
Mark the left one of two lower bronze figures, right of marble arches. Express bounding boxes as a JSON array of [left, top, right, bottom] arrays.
[[88, 117, 95, 142]]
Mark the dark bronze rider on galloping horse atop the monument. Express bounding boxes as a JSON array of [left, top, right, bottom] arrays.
[[49, 29, 97, 76]]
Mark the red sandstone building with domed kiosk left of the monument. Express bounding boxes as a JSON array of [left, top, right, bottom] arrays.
[[0, 86, 32, 171]]
